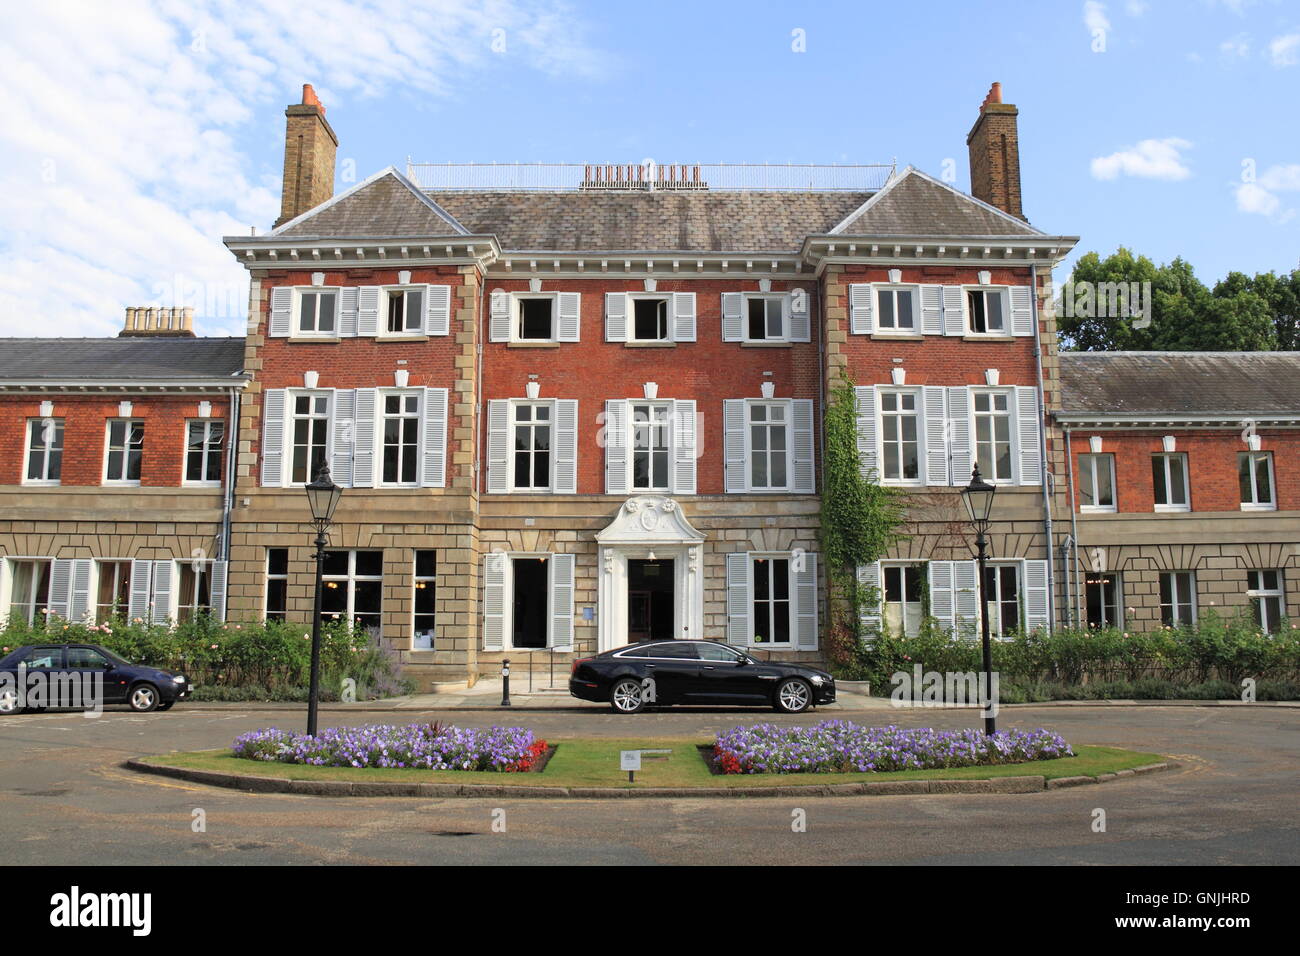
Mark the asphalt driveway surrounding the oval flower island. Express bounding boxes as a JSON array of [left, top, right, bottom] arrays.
[[0, 705, 1300, 865]]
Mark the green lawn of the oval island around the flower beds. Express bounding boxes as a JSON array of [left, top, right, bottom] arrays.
[[137, 737, 1164, 788]]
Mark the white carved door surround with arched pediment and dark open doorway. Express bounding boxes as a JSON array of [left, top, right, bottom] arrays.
[[595, 494, 705, 650]]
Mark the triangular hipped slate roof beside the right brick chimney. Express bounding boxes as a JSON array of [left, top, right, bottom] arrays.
[[833, 166, 1043, 237]]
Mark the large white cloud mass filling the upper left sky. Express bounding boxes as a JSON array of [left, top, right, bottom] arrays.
[[0, 0, 602, 336]]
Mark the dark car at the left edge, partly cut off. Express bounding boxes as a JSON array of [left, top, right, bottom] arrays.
[[0, 644, 194, 714]]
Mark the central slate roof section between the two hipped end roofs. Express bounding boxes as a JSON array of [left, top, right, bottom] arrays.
[[430, 190, 870, 252]]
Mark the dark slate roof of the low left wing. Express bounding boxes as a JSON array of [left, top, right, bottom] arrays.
[[0, 336, 244, 384]]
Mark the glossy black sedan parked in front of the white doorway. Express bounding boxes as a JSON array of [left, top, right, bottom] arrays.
[[569, 640, 835, 714]]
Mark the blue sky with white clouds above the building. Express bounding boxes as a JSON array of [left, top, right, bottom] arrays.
[[0, 0, 1300, 336]]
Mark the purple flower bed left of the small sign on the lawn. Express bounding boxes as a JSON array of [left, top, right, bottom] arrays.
[[231, 723, 547, 773]]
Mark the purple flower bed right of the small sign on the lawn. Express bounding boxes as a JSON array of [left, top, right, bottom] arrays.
[[714, 721, 1074, 774]]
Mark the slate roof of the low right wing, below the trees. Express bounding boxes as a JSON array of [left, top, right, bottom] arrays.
[[1061, 352, 1300, 419]]
